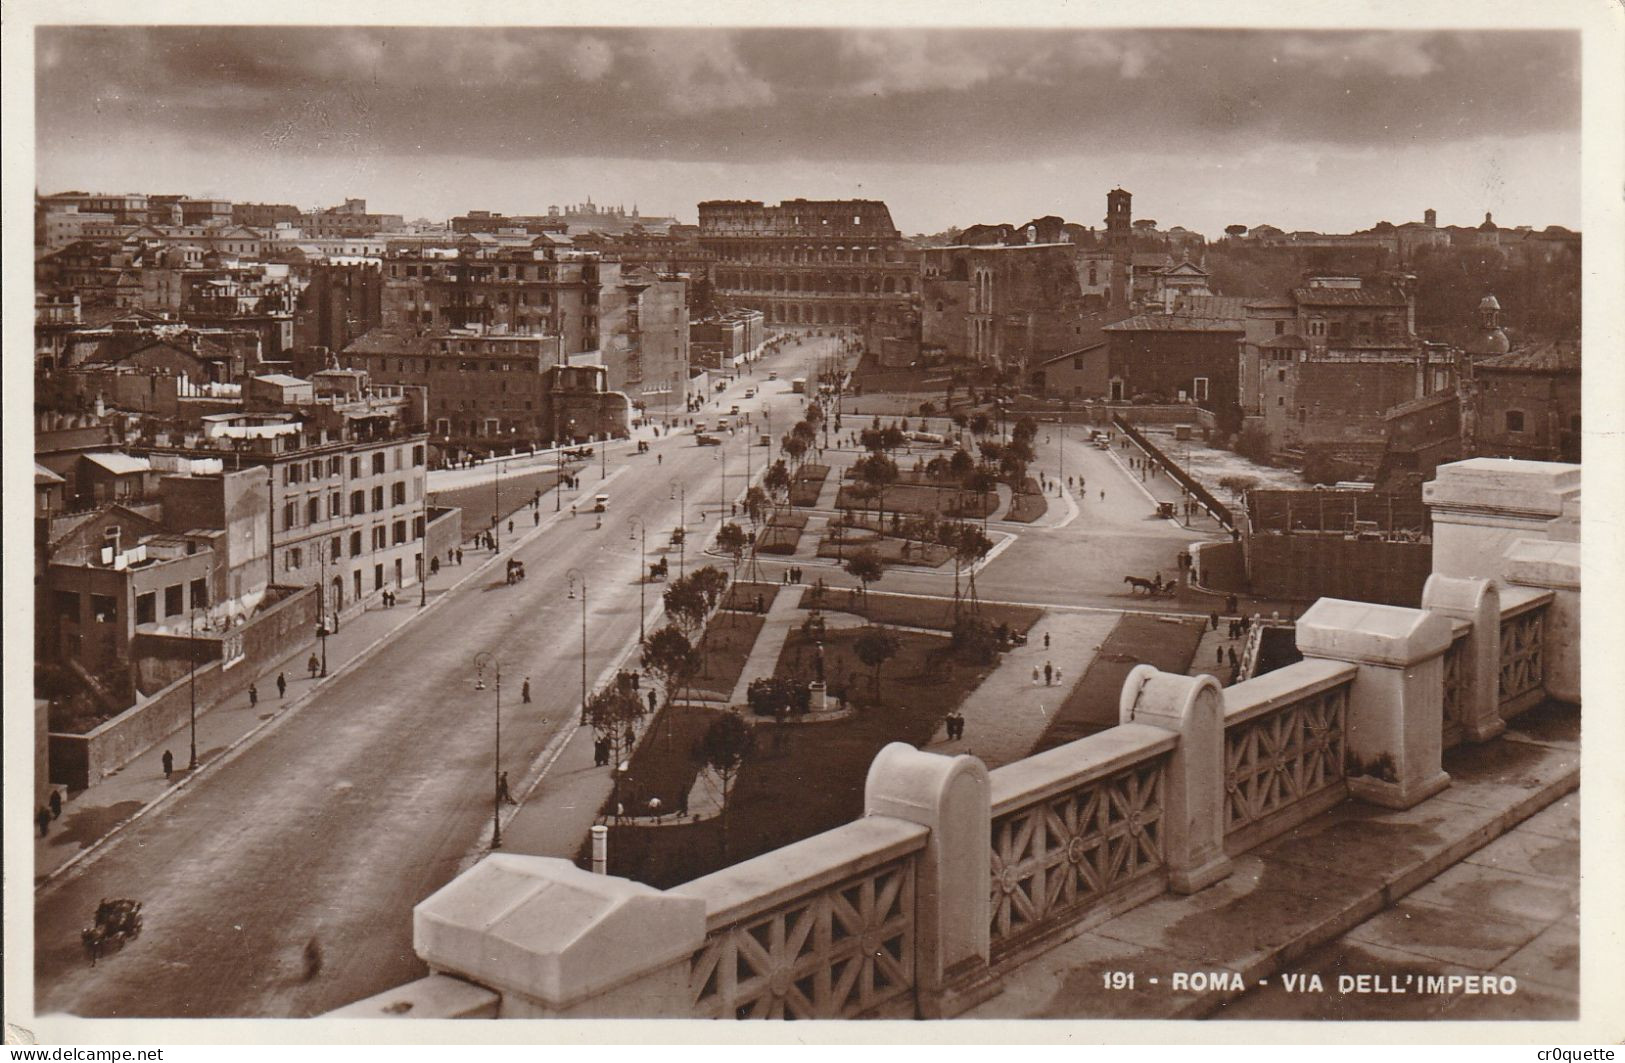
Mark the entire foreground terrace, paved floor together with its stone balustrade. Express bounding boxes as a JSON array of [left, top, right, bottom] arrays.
[[333, 460, 1580, 1019]]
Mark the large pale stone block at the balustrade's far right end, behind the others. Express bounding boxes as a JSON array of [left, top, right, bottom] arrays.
[[1422, 458, 1580, 579]]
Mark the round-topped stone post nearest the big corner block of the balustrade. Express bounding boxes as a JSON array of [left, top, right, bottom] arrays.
[[863, 741, 993, 1019]]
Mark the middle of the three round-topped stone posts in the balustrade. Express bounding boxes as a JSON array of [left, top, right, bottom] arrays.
[[1118, 665, 1230, 894]]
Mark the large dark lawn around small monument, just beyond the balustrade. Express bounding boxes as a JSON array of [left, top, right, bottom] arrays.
[[609, 629, 991, 887]]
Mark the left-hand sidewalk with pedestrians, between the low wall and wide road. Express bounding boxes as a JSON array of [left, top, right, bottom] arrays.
[[34, 500, 568, 886]]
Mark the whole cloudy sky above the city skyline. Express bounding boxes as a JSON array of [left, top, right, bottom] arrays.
[[36, 26, 1580, 236]]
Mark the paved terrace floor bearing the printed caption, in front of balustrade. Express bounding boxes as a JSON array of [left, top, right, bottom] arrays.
[[960, 704, 1580, 1019]]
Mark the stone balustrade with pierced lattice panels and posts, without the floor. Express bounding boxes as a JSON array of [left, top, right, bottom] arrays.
[[336, 463, 1580, 1019]]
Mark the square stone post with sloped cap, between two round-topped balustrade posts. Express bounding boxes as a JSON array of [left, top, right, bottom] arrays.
[[1297, 598, 1451, 808]]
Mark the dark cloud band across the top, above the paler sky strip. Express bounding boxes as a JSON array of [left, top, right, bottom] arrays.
[[37, 28, 1580, 163]]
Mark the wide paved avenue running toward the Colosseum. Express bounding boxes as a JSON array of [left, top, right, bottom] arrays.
[[34, 340, 830, 1017]]
